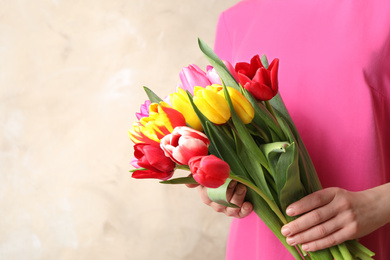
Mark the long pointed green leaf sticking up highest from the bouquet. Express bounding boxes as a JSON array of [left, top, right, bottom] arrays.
[[198, 38, 240, 90]]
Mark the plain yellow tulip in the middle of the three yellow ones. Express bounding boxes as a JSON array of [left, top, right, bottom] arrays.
[[193, 87, 231, 125]]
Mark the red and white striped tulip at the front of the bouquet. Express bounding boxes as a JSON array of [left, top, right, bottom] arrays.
[[160, 126, 210, 165]]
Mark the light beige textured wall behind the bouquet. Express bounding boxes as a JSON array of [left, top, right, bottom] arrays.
[[0, 0, 238, 260]]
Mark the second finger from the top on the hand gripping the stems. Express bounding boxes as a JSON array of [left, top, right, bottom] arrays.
[[281, 204, 337, 236]]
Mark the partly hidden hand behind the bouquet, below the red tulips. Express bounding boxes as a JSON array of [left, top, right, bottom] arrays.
[[187, 181, 253, 218]]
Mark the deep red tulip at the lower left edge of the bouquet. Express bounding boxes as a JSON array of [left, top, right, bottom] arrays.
[[132, 143, 176, 180]]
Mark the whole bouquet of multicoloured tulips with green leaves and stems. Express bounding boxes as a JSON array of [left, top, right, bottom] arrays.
[[129, 40, 374, 260]]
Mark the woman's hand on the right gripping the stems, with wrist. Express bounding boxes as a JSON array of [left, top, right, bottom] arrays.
[[282, 183, 390, 251]]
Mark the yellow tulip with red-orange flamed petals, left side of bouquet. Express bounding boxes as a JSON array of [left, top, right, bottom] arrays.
[[129, 102, 186, 144]]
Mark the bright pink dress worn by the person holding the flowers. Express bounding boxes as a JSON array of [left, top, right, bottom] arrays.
[[215, 0, 390, 260]]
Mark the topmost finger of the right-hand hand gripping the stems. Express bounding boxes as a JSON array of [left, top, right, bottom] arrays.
[[286, 188, 335, 216]]
